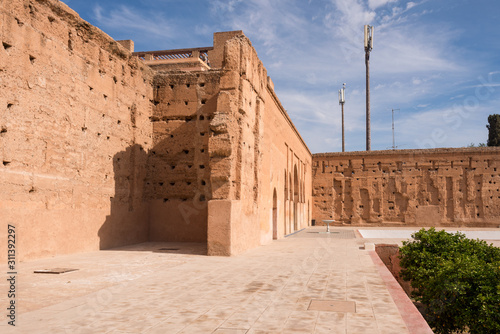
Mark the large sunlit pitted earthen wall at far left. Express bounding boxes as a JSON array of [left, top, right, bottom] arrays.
[[0, 0, 153, 260]]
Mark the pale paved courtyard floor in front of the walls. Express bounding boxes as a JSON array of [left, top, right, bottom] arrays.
[[0, 227, 486, 334]]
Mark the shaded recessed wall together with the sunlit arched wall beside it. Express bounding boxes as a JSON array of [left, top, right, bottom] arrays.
[[142, 31, 312, 255]]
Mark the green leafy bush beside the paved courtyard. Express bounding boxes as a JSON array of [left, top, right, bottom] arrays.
[[400, 228, 500, 334]]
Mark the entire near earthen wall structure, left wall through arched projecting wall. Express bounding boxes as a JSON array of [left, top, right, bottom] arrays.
[[0, 0, 312, 261]]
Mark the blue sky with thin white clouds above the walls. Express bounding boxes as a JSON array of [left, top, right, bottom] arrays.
[[64, 0, 500, 153]]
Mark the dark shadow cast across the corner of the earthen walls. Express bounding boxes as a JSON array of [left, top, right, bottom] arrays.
[[98, 116, 211, 249]]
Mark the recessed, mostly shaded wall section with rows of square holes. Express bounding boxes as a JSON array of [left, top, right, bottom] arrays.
[[146, 70, 220, 242]]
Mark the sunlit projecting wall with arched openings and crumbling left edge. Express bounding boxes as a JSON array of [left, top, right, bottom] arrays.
[[208, 35, 311, 255]]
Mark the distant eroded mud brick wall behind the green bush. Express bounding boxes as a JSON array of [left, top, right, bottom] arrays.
[[313, 147, 500, 227]]
